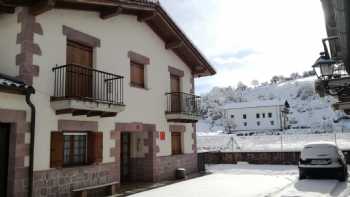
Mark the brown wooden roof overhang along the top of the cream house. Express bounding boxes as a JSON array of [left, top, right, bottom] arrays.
[[0, 0, 216, 77]]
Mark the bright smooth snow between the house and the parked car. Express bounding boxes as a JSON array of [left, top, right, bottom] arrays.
[[132, 165, 297, 197]]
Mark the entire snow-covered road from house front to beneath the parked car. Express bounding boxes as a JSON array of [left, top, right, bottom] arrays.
[[132, 164, 350, 197]]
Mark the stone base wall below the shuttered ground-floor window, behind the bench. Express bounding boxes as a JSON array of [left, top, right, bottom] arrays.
[[33, 163, 119, 197]]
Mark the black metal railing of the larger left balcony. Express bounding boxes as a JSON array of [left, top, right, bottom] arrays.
[[52, 64, 124, 105]]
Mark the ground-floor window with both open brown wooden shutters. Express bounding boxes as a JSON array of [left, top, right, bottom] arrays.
[[50, 132, 103, 168]]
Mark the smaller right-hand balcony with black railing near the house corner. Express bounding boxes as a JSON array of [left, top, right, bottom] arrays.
[[165, 92, 200, 123]]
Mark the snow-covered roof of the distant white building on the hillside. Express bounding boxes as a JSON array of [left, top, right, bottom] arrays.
[[222, 100, 285, 109]]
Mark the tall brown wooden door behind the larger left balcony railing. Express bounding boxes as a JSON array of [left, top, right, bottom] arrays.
[[66, 41, 93, 98]]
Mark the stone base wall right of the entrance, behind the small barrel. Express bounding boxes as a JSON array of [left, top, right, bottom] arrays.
[[157, 154, 198, 180]]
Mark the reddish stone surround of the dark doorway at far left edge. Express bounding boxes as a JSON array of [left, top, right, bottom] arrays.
[[0, 109, 29, 196]]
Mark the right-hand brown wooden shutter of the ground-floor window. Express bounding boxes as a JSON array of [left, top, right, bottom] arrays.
[[87, 132, 103, 164]]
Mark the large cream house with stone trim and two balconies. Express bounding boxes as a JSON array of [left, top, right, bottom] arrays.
[[0, 0, 215, 197]]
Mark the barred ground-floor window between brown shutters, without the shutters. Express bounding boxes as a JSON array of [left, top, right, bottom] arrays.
[[63, 133, 87, 166]]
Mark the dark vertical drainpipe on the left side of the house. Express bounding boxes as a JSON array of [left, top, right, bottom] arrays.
[[25, 86, 35, 197]]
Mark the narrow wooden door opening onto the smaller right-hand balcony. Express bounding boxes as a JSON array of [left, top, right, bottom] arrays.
[[170, 75, 181, 112]]
